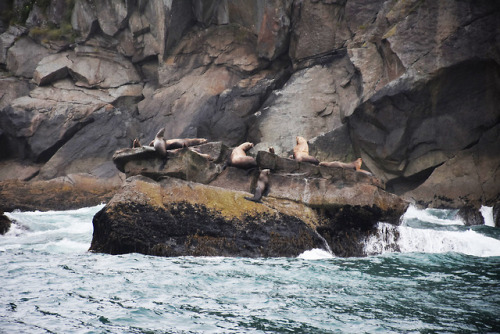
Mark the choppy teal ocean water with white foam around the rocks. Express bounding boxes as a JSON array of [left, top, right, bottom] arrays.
[[0, 205, 500, 333]]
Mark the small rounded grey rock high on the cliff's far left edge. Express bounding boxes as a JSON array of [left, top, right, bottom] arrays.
[[6, 37, 49, 78]]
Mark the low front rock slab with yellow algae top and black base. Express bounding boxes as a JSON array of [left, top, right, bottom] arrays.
[[90, 177, 323, 257]]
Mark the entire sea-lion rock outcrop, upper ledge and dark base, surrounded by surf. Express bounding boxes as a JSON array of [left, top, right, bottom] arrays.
[[91, 143, 408, 257]]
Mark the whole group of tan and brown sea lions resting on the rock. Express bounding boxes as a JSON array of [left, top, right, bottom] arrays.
[[132, 128, 372, 202]]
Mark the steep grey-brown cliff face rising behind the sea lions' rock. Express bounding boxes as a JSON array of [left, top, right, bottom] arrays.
[[0, 0, 500, 211]]
